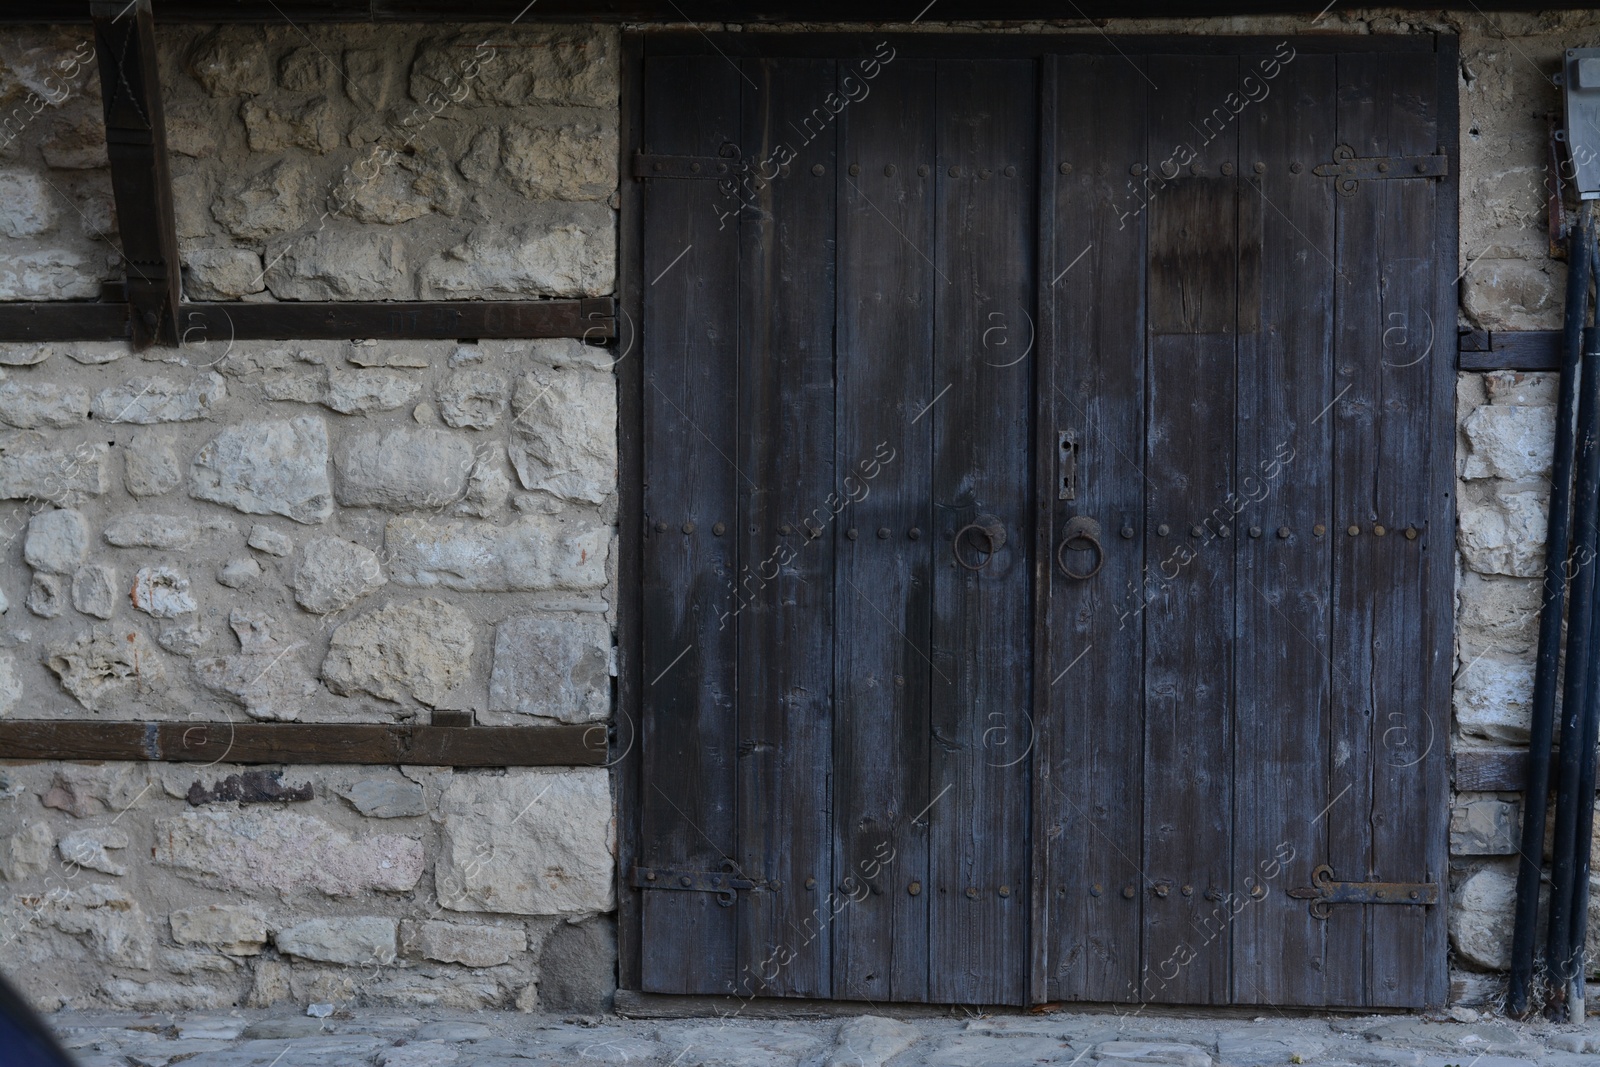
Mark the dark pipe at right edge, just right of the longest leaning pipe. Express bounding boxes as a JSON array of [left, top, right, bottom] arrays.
[[1531, 219, 1600, 995]]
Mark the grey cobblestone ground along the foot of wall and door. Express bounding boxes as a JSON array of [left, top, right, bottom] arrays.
[[37, 1009, 1600, 1067]]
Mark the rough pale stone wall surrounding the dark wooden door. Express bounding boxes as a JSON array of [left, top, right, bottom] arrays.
[[0, 2, 1600, 1009]]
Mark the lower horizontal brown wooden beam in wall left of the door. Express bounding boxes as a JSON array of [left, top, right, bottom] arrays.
[[0, 720, 606, 766]]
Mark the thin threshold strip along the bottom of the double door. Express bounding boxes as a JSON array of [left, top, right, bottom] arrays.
[[613, 989, 1401, 1022]]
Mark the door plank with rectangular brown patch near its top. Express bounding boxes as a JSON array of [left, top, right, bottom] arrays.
[[1139, 58, 1238, 1003]]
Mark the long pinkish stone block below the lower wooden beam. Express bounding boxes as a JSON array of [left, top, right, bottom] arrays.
[[154, 808, 422, 897]]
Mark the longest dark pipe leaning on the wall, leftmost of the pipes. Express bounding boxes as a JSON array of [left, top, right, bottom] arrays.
[[1506, 202, 1590, 1017]]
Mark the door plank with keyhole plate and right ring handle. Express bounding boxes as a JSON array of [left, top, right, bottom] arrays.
[[1035, 56, 1155, 1001]]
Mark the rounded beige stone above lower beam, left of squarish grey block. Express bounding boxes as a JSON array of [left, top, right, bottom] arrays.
[[322, 597, 474, 707]]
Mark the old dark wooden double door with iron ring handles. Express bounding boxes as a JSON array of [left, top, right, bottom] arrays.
[[622, 35, 1456, 1006]]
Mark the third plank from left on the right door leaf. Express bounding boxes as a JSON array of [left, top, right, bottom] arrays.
[[1221, 53, 1336, 1005]]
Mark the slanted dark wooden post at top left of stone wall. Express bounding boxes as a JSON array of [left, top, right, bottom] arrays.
[[90, 0, 181, 349]]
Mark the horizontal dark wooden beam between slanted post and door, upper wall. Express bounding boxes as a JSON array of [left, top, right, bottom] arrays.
[[179, 296, 616, 344]]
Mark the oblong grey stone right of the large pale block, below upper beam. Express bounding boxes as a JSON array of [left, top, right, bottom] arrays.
[[333, 429, 474, 510]]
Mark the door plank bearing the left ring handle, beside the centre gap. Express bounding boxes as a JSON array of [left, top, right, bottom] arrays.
[[928, 61, 1038, 1005]]
